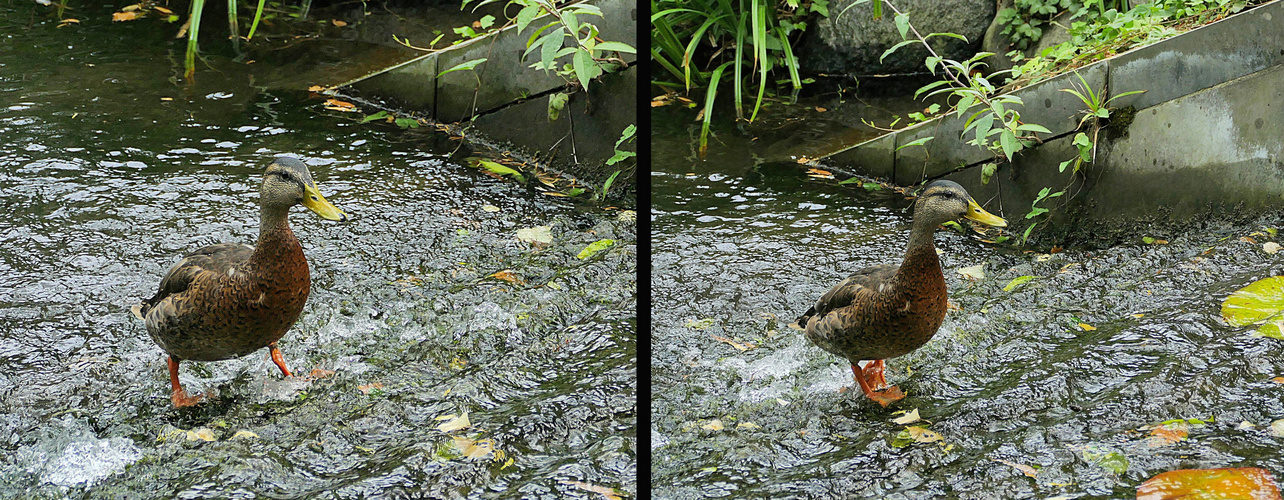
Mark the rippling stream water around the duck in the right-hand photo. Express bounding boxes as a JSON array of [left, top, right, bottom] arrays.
[[650, 103, 1284, 499]]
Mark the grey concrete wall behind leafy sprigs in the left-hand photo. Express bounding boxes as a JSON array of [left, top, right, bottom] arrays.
[[342, 0, 638, 185]]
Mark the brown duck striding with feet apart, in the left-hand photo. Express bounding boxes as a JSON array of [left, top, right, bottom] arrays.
[[132, 157, 348, 406]]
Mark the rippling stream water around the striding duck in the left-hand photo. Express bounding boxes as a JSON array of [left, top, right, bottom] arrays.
[[0, 3, 637, 499]]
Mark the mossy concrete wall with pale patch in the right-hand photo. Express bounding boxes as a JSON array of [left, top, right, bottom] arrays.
[[822, 3, 1284, 237]]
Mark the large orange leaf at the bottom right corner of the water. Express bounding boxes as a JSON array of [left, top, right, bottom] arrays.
[[1136, 468, 1280, 500]]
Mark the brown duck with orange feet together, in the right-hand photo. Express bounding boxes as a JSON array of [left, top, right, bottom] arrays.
[[797, 180, 1008, 406]]
